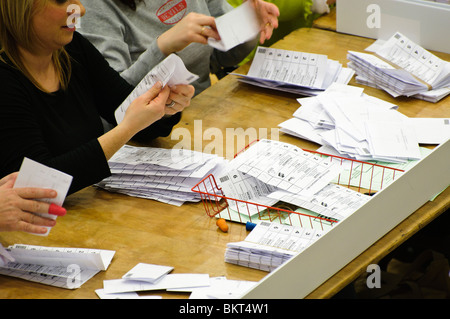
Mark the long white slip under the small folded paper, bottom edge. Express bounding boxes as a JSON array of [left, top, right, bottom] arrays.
[[103, 274, 210, 293]]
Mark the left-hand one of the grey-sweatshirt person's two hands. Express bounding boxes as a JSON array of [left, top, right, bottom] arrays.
[[157, 12, 220, 55]]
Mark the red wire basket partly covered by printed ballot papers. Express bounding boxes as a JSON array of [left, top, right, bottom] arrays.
[[192, 143, 404, 230]]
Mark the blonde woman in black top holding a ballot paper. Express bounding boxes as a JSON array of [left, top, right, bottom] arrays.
[[0, 0, 194, 193]]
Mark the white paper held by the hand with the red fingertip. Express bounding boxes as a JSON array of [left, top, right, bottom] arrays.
[[14, 158, 72, 236]]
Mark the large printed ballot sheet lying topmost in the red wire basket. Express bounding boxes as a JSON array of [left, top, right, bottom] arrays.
[[230, 139, 341, 196]]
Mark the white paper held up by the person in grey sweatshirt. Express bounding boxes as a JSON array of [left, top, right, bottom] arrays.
[[208, 1, 260, 51]]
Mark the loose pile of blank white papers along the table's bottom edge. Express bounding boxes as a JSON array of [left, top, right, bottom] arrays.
[[95, 263, 256, 299]]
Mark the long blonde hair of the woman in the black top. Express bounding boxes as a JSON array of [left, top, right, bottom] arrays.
[[0, 0, 71, 92]]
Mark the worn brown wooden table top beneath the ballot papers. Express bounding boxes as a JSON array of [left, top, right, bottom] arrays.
[[0, 28, 450, 299]]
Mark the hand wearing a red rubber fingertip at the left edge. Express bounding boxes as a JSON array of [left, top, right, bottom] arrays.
[[0, 173, 66, 234]]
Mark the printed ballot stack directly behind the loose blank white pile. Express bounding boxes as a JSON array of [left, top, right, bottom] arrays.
[[232, 47, 355, 96]]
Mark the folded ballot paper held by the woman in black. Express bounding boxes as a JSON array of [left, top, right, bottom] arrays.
[[114, 53, 198, 124]]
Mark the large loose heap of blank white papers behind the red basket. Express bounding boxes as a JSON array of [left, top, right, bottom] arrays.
[[279, 84, 450, 163]]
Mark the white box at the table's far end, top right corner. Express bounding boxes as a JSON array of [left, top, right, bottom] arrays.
[[336, 0, 450, 53]]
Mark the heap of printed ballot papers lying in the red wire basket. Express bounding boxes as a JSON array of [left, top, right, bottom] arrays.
[[216, 139, 370, 230]]
